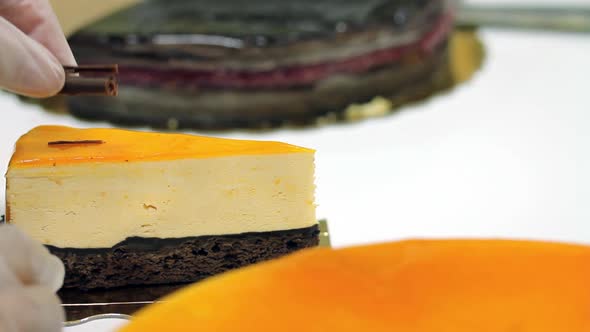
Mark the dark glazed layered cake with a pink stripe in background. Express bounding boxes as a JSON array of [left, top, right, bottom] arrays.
[[62, 0, 453, 129]]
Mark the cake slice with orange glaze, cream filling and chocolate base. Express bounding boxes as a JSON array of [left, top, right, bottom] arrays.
[[6, 126, 318, 289]]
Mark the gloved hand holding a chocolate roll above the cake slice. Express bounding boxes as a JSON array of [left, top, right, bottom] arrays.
[[0, 0, 76, 97]]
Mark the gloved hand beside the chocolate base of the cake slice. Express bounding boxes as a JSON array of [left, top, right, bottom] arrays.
[[0, 225, 65, 332]]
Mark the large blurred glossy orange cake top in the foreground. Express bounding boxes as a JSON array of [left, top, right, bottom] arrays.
[[122, 240, 590, 332]]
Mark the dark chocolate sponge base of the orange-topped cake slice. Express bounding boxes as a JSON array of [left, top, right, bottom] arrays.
[[48, 225, 319, 290]]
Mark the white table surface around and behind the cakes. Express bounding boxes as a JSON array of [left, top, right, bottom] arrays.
[[0, 19, 590, 331]]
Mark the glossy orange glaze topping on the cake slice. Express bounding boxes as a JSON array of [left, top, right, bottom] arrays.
[[10, 126, 313, 167]]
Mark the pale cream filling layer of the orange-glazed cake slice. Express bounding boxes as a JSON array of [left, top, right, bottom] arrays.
[[7, 153, 316, 248]]
